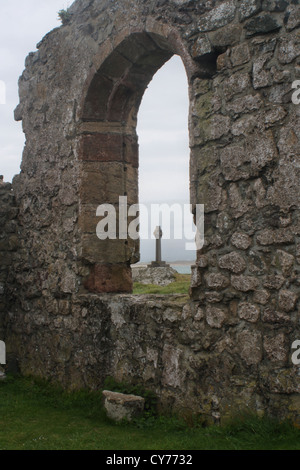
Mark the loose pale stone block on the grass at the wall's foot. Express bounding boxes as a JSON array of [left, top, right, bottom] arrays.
[[102, 390, 145, 421]]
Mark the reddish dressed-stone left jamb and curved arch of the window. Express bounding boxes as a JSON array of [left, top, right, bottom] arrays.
[[79, 32, 193, 292]]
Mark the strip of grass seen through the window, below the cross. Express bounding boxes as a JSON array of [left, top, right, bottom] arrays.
[[133, 273, 191, 295]]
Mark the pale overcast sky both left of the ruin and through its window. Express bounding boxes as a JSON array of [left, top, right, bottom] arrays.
[[0, 0, 195, 260]]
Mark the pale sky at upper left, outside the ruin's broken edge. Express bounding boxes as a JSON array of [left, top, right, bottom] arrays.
[[0, 0, 68, 181]]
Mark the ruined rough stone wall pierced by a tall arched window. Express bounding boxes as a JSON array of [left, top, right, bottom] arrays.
[[0, 0, 300, 421]]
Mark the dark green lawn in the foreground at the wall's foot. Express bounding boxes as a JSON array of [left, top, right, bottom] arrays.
[[0, 376, 300, 450]]
